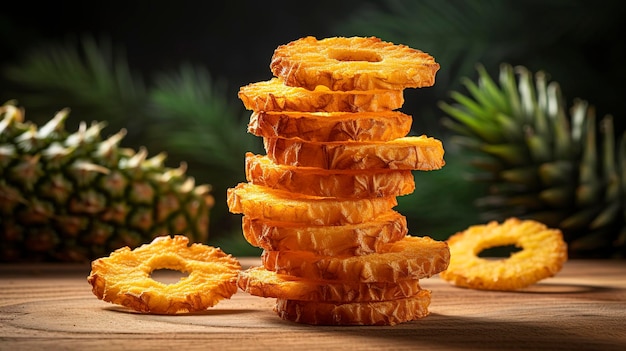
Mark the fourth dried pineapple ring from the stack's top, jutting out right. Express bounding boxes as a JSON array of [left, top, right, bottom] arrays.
[[263, 135, 445, 171]]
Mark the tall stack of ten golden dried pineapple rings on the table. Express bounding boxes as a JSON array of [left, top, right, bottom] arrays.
[[227, 37, 450, 325]]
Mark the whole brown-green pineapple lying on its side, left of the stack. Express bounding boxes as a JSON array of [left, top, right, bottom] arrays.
[[0, 103, 214, 262]]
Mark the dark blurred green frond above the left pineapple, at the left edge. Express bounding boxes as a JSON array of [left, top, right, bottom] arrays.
[[2, 36, 147, 135]]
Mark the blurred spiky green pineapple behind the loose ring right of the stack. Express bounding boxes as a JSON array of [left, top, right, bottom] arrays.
[[440, 64, 626, 258]]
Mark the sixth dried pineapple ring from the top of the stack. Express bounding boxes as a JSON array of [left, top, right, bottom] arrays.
[[226, 183, 398, 225]]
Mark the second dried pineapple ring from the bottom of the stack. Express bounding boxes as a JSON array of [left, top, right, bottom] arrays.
[[237, 267, 421, 303]]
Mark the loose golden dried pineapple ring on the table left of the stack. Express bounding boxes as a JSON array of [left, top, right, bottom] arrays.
[[87, 235, 241, 314]]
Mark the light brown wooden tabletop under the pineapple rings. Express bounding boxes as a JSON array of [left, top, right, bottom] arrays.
[[0, 258, 626, 351]]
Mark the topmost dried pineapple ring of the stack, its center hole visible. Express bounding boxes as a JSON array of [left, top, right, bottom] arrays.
[[270, 36, 439, 91]]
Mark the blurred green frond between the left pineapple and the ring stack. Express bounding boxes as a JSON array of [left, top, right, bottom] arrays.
[[150, 64, 262, 182]]
